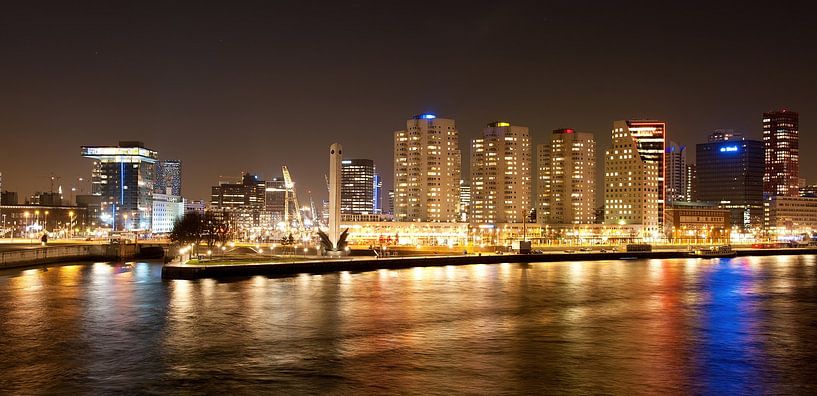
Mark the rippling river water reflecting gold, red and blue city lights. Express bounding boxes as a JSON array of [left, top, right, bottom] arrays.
[[0, 256, 817, 394]]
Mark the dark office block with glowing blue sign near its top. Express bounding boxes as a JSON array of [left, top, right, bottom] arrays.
[[695, 131, 764, 228]]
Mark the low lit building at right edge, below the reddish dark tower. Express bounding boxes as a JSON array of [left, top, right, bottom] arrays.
[[763, 196, 817, 236]]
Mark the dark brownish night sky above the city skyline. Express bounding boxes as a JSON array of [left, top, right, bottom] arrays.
[[0, 0, 817, 201]]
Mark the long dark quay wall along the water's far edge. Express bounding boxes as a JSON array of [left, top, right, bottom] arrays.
[[162, 248, 817, 279]]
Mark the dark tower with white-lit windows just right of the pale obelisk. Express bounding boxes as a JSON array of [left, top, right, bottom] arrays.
[[340, 159, 375, 214]]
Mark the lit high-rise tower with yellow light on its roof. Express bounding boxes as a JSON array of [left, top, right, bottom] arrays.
[[468, 122, 531, 224]]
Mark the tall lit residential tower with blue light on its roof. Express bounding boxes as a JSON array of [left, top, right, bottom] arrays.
[[394, 114, 462, 222]]
